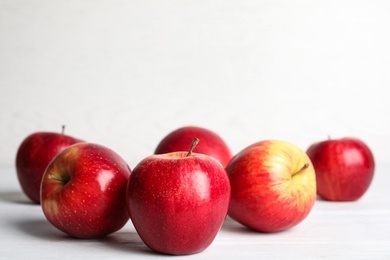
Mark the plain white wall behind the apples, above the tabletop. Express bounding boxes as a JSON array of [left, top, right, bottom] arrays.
[[0, 0, 390, 168]]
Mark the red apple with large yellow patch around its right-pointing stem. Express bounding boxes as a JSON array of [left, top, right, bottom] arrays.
[[226, 140, 316, 232]]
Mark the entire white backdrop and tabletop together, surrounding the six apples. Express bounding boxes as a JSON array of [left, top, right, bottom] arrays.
[[0, 0, 390, 260]]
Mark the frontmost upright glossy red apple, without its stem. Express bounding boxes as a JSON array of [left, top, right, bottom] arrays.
[[127, 152, 230, 255]]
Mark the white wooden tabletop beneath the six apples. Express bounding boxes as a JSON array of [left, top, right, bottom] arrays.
[[0, 165, 390, 259]]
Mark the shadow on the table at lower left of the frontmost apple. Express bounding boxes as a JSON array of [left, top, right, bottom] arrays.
[[101, 230, 155, 255]]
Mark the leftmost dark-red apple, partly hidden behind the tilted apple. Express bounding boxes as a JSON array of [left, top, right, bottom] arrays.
[[16, 126, 81, 204]]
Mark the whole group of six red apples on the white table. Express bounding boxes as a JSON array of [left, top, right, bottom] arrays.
[[16, 126, 375, 255]]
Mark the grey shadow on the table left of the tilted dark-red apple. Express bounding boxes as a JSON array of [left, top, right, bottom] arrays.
[[12, 219, 67, 241]]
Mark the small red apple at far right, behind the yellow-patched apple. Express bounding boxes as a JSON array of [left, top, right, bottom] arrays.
[[307, 138, 375, 201]]
